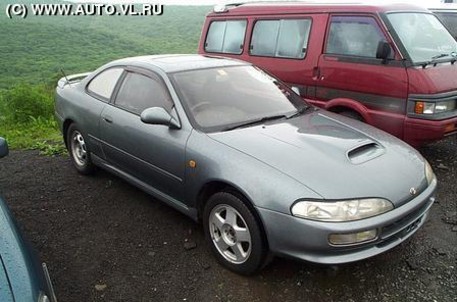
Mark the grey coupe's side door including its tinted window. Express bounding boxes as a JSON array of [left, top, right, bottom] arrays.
[[100, 68, 190, 200]]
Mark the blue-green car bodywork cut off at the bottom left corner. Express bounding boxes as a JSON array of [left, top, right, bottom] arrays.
[[0, 197, 40, 302]]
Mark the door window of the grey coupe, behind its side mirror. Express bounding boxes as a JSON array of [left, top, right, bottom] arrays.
[[114, 72, 172, 114]]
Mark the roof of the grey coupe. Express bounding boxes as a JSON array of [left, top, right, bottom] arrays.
[[110, 54, 251, 73]]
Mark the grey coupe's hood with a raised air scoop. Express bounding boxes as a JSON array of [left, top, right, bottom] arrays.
[[210, 110, 426, 206]]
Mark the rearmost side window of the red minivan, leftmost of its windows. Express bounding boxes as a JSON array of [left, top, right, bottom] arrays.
[[205, 20, 247, 54]]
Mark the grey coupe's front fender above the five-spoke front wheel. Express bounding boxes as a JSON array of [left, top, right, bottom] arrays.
[[185, 131, 322, 214]]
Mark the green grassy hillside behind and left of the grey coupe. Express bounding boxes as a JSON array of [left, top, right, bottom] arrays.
[[0, 0, 210, 150]]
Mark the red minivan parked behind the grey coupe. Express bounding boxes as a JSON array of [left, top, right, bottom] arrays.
[[199, 2, 457, 146]]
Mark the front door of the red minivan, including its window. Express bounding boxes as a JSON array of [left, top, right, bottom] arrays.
[[316, 14, 408, 137]]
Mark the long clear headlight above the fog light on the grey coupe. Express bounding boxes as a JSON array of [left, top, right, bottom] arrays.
[[291, 198, 394, 222]]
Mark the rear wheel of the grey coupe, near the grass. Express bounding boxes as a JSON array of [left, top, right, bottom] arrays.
[[67, 124, 95, 174]]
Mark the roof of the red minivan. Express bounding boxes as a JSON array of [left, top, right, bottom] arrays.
[[208, 1, 428, 17]]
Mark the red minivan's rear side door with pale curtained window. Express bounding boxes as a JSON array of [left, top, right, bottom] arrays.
[[239, 14, 327, 98]]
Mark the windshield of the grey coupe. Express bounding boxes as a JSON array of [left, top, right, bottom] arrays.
[[172, 66, 307, 132]]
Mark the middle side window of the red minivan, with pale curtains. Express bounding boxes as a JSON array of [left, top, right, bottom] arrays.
[[249, 19, 311, 59]]
